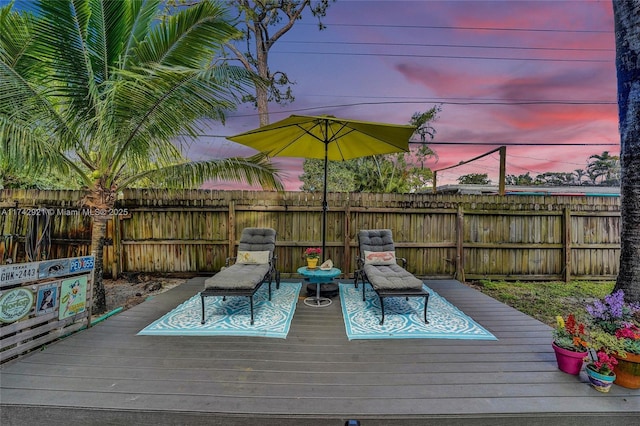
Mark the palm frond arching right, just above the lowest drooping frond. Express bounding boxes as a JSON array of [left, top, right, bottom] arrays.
[[106, 60, 251, 173]]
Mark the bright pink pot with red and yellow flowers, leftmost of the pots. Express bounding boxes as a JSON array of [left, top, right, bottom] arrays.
[[551, 314, 588, 375]]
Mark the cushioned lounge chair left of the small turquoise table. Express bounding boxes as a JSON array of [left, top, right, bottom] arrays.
[[200, 228, 280, 325]]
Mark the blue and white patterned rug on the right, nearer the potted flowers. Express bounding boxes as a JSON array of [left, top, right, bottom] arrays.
[[340, 284, 497, 340]]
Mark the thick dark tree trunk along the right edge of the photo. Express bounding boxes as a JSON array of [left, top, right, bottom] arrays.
[[613, 0, 640, 302]]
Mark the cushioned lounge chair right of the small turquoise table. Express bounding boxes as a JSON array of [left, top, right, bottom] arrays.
[[354, 229, 429, 325]]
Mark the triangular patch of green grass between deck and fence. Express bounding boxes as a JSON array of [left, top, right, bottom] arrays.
[[467, 280, 615, 327]]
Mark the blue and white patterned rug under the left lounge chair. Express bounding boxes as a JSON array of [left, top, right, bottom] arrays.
[[138, 282, 302, 339]]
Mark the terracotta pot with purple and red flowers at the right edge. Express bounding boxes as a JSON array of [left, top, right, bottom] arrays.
[[586, 290, 640, 389]]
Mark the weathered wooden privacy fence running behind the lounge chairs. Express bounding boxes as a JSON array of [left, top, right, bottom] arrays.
[[0, 190, 620, 280]]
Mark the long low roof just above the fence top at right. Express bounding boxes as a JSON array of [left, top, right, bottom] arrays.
[[436, 185, 620, 197]]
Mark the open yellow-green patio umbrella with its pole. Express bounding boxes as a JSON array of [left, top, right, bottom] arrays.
[[227, 115, 416, 261]]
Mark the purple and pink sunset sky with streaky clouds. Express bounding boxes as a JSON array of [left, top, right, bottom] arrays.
[[188, 0, 620, 191]]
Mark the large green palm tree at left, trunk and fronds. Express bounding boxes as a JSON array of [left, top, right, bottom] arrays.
[[0, 0, 282, 312]]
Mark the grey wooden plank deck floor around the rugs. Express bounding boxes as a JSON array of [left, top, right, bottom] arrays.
[[0, 278, 640, 426]]
